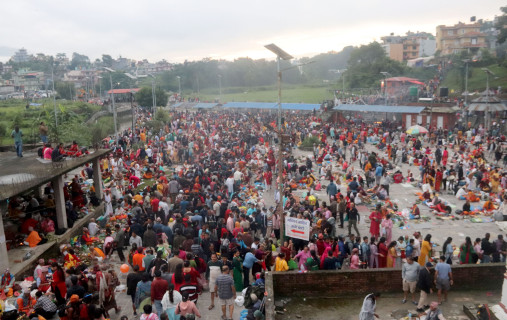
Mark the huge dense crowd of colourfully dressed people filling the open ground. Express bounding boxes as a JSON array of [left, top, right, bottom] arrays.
[[2, 104, 507, 320]]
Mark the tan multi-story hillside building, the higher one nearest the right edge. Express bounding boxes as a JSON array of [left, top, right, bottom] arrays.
[[437, 22, 488, 55]]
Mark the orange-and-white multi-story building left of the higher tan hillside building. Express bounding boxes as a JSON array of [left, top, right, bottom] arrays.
[[381, 31, 436, 61]]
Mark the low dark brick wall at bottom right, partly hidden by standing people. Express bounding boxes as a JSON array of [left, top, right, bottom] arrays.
[[266, 263, 505, 298]]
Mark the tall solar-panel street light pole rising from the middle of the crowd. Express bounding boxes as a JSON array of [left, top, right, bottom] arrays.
[[264, 44, 294, 245]]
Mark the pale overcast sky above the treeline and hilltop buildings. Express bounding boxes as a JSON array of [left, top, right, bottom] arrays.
[[0, 0, 506, 62]]
